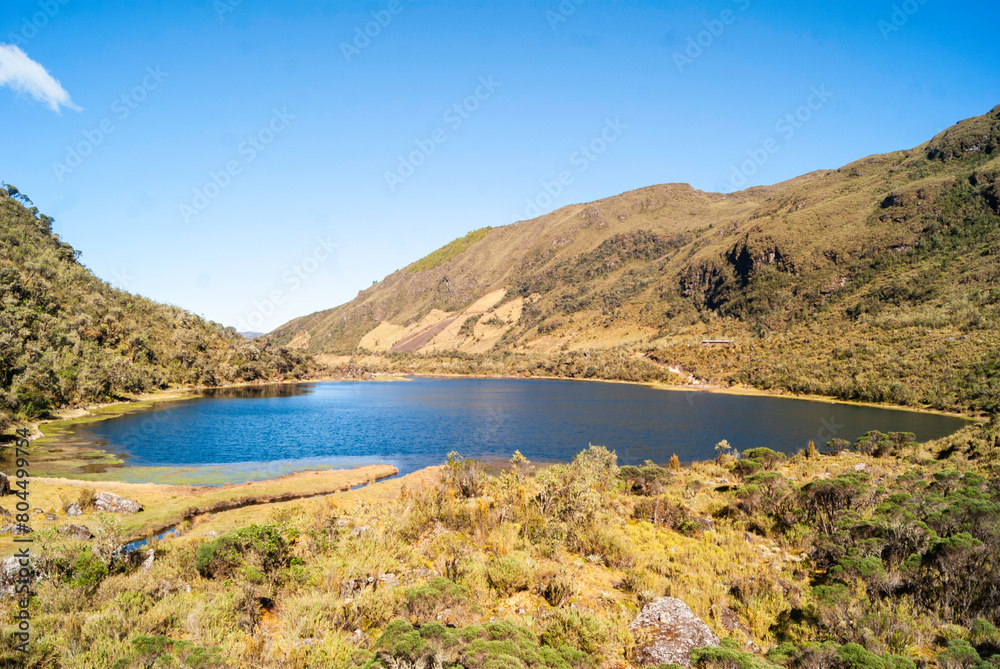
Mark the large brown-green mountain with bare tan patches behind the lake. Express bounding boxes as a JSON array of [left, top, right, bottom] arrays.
[[269, 107, 1000, 409]]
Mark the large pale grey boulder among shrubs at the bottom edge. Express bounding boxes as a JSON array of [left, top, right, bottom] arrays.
[[629, 597, 719, 667]]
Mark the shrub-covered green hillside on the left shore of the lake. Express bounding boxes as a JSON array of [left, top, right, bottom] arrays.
[[0, 186, 307, 429]]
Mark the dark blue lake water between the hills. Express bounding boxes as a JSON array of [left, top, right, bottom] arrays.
[[64, 378, 966, 480]]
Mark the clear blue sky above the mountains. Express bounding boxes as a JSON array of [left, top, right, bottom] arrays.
[[0, 0, 1000, 331]]
